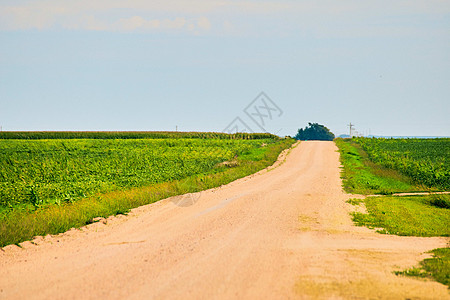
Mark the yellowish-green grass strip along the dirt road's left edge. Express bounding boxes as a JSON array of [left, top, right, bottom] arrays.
[[0, 139, 295, 247]]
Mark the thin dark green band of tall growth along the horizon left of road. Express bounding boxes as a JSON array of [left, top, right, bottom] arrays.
[[0, 131, 279, 140]]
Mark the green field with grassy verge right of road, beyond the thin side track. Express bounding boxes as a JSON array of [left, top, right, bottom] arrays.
[[335, 138, 450, 194]]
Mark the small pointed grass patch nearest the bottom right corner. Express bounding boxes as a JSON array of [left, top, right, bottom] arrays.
[[394, 248, 450, 288]]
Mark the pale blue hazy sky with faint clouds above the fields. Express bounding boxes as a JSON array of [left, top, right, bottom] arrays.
[[0, 0, 450, 136]]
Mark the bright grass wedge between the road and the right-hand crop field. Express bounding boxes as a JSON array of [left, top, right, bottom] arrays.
[[335, 139, 429, 195]]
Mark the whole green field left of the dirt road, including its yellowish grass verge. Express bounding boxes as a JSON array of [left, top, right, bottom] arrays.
[[0, 133, 294, 246]]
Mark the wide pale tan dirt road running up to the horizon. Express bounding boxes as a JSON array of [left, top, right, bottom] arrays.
[[0, 142, 450, 299]]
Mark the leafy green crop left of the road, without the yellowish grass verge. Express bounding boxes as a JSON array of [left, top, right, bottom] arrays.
[[0, 139, 280, 212]]
